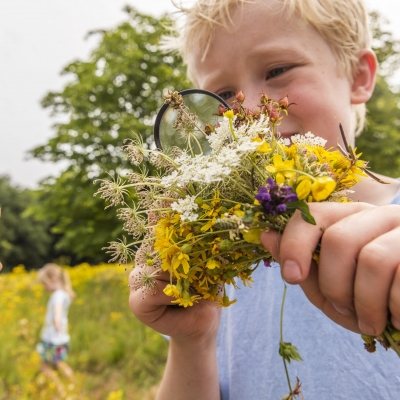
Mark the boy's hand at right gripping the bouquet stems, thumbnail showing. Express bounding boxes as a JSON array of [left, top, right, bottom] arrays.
[[261, 203, 400, 335]]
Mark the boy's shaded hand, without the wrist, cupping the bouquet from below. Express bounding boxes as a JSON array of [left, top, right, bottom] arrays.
[[129, 268, 220, 343]]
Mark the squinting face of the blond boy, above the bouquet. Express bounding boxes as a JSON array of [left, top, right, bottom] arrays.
[[189, 0, 360, 146]]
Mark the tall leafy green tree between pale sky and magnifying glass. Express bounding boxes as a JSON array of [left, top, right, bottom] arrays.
[[31, 7, 188, 262]]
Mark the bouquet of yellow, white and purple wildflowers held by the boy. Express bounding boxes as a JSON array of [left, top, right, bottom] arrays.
[[97, 92, 400, 358]]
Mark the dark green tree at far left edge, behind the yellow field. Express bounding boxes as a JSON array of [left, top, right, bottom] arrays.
[[0, 176, 51, 269]]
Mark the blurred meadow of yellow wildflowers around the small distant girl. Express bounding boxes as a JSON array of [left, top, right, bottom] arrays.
[[0, 264, 167, 400]]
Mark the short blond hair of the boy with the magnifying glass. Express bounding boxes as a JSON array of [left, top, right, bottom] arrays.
[[175, 0, 371, 133]]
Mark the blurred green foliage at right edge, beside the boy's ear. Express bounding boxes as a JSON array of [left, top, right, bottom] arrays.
[[357, 13, 400, 177]]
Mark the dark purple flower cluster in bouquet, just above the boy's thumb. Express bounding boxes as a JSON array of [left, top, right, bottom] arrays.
[[256, 178, 298, 215]]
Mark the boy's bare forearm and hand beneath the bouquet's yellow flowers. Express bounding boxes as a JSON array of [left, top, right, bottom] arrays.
[[129, 268, 220, 400]]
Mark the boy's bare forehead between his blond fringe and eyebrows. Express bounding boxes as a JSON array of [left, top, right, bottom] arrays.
[[187, 0, 328, 87]]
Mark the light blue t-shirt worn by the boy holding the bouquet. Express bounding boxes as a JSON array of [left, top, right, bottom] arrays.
[[218, 197, 400, 400]]
